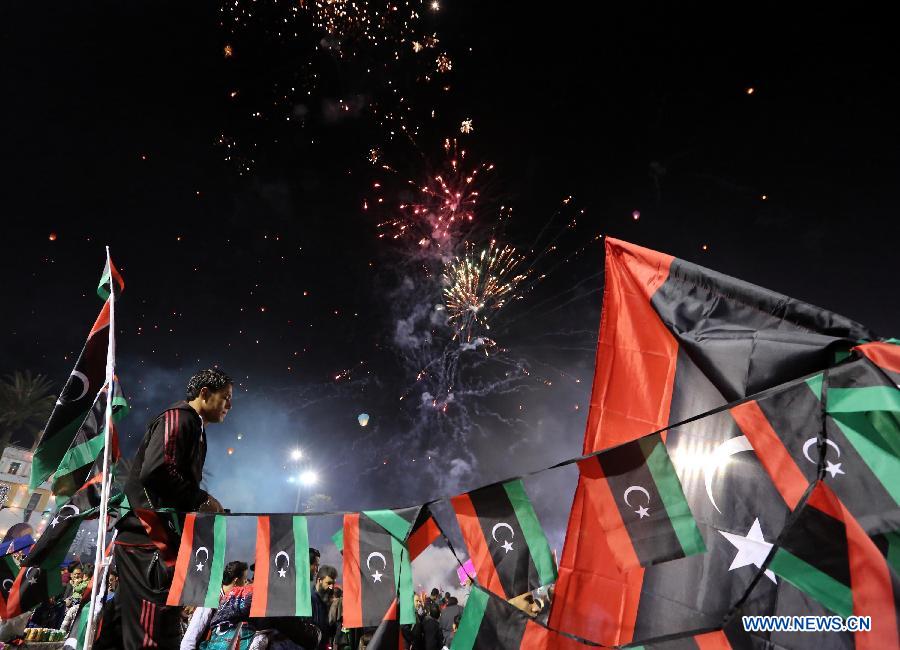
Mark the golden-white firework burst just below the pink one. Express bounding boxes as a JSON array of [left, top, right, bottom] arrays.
[[443, 240, 527, 342]]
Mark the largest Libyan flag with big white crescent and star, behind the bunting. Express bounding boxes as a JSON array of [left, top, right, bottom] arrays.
[[550, 239, 876, 645]]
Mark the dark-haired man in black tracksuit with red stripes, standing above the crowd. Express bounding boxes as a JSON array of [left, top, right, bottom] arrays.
[[115, 369, 233, 650]]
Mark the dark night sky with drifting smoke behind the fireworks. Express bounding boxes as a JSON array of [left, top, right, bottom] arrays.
[[0, 0, 900, 576]]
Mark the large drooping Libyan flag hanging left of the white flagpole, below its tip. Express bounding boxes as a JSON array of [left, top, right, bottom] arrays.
[[29, 302, 109, 490]]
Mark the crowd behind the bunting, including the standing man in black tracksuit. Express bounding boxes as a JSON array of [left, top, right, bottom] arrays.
[[0, 369, 548, 650]]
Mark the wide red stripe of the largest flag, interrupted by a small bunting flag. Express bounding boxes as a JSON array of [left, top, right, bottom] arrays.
[[550, 238, 678, 645]]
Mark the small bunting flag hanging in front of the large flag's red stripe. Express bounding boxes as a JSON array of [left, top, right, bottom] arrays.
[[578, 433, 706, 570]]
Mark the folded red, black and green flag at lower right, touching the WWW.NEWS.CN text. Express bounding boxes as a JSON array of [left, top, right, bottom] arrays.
[[768, 481, 900, 648]]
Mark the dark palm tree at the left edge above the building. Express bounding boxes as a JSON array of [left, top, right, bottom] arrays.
[[0, 370, 56, 466]]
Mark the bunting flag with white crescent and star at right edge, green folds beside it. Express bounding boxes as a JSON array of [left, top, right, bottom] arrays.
[[730, 354, 900, 535]]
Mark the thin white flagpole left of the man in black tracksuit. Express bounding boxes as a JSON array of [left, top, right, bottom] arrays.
[[84, 246, 116, 650]]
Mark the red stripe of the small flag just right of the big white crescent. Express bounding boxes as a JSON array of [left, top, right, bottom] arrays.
[[729, 401, 809, 510]]
